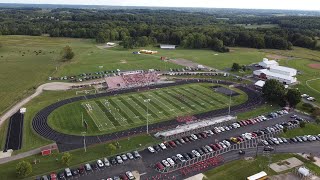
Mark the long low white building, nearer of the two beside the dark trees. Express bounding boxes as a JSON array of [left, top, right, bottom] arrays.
[[253, 69, 297, 84]]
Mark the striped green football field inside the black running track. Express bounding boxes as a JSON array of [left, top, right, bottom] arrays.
[[49, 83, 247, 135]]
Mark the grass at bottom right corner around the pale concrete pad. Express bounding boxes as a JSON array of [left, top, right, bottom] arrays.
[[204, 154, 320, 180]]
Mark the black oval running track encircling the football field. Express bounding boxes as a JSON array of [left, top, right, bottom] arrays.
[[32, 79, 262, 152]]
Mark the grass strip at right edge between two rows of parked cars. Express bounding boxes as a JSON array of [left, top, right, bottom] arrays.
[[280, 123, 320, 138]]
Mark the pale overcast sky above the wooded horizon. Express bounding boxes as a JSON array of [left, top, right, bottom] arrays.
[[0, 0, 320, 10]]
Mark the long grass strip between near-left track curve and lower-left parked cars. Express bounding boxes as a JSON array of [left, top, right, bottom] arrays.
[[0, 135, 157, 180]]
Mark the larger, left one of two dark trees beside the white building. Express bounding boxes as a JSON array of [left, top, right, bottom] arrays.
[[262, 79, 286, 104]]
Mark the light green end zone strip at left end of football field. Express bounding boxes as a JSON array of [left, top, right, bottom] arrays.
[[82, 101, 115, 131]]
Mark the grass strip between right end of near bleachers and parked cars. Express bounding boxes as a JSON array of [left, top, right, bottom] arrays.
[[237, 104, 280, 120]]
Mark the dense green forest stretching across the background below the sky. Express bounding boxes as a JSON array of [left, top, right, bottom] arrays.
[[0, 8, 320, 52]]
